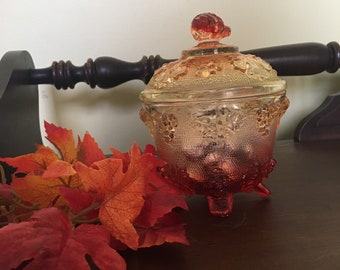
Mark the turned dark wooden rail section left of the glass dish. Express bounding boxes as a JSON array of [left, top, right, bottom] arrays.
[[11, 55, 174, 89]]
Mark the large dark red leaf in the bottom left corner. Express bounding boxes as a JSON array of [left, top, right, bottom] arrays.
[[0, 207, 126, 270]]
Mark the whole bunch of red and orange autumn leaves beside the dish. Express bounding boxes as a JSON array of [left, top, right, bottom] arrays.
[[0, 122, 188, 269]]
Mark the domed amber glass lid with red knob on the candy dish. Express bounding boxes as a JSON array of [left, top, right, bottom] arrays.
[[140, 13, 286, 102]]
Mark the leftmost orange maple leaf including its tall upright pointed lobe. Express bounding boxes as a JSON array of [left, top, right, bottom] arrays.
[[0, 122, 85, 207]]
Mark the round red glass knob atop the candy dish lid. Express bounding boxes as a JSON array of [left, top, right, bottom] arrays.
[[191, 13, 231, 41]]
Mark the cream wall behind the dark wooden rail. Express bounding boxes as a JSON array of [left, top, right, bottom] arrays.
[[0, 0, 340, 152]]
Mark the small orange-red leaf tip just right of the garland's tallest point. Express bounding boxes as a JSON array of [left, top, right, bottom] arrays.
[[77, 132, 106, 166]]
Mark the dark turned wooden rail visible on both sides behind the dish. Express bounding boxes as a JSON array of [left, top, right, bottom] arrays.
[[11, 41, 340, 89]]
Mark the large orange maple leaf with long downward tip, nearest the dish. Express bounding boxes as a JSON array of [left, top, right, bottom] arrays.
[[74, 144, 163, 249]]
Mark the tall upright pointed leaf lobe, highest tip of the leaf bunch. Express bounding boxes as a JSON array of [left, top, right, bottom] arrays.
[[44, 121, 78, 163]]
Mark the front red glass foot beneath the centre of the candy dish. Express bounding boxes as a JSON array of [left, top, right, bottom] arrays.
[[207, 193, 234, 217]]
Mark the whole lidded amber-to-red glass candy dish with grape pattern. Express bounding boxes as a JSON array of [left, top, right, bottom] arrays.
[[140, 13, 289, 216]]
